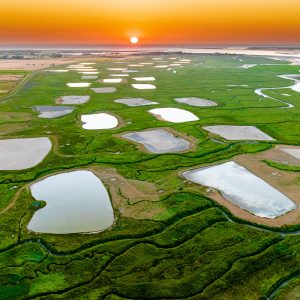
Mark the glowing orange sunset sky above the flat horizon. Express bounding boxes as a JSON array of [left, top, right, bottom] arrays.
[[0, 0, 300, 45]]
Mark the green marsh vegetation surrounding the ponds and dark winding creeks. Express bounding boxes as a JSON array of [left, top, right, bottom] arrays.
[[0, 55, 300, 300]]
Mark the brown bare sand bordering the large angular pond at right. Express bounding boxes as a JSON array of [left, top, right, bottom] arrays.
[[185, 145, 300, 227]]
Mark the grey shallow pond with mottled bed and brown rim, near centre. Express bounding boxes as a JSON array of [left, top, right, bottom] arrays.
[[122, 129, 190, 153]]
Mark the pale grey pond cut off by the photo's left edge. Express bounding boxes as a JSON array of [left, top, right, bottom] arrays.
[[0, 137, 52, 170]]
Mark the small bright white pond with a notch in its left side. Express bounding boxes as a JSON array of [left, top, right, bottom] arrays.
[[81, 113, 119, 129]]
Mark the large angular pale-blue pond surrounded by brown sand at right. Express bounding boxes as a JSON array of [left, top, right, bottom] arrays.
[[182, 161, 297, 219]]
